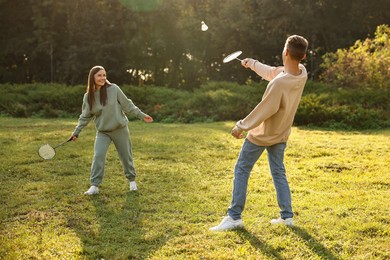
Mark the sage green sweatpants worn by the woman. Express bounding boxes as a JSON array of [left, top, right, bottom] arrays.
[[91, 126, 136, 186]]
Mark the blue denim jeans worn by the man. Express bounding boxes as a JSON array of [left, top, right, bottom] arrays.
[[228, 139, 294, 220]]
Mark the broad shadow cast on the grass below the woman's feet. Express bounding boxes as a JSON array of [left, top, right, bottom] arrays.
[[67, 192, 171, 259]]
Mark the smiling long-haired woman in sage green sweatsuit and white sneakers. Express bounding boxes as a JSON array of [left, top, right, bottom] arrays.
[[71, 66, 153, 195]]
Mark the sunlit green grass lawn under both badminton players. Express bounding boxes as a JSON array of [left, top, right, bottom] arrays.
[[0, 118, 390, 259]]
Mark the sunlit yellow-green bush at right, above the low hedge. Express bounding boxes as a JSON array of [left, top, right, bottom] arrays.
[[321, 25, 390, 90]]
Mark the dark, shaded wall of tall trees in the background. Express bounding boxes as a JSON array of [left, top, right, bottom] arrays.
[[0, 0, 390, 89]]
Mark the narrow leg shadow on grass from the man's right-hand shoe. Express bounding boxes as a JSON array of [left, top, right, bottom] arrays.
[[289, 226, 341, 260]]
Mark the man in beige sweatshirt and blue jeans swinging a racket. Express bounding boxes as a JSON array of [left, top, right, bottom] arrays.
[[210, 35, 308, 231]]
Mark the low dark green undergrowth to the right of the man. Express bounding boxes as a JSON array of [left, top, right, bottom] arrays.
[[295, 82, 390, 129]]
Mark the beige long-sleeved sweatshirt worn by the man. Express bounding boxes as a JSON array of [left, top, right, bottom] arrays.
[[237, 61, 307, 146]]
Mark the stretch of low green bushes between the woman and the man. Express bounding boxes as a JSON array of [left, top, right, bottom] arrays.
[[122, 82, 265, 123]]
